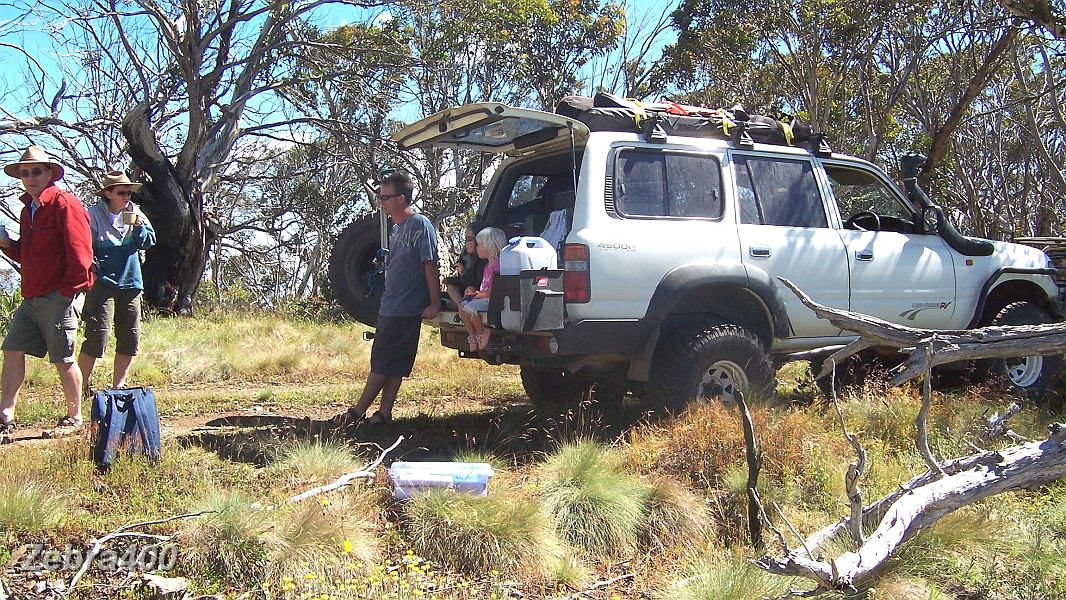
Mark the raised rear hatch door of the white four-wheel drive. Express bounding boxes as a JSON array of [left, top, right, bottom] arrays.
[[392, 102, 588, 156]]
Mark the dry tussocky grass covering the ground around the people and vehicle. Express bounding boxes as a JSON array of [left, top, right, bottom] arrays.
[[0, 306, 1066, 600]]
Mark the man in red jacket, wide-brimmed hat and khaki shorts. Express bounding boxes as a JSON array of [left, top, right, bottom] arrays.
[[0, 146, 93, 443]]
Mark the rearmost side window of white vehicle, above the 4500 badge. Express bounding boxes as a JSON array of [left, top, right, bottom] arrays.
[[613, 149, 722, 218]]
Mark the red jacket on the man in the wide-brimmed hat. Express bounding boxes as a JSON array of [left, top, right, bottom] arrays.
[[3, 184, 93, 298]]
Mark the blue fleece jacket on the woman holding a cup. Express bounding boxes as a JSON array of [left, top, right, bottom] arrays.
[[88, 199, 156, 290]]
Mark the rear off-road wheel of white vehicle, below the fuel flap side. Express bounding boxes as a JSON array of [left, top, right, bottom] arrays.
[[648, 321, 777, 413]]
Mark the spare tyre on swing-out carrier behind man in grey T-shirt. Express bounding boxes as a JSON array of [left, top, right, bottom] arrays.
[[329, 212, 385, 327]]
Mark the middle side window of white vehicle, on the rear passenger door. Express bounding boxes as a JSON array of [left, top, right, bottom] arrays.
[[732, 155, 829, 227]]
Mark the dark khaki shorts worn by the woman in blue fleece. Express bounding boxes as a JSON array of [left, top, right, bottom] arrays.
[[81, 281, 141, 358]]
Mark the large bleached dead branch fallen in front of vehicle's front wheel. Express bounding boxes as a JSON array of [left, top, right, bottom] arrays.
[[755, 278, 1066, 596]]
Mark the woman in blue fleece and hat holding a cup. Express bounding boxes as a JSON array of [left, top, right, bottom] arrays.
[[78, 171, 156, 388]]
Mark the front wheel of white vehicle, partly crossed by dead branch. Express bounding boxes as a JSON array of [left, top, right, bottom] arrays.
[[989, 302, 1064, 401]]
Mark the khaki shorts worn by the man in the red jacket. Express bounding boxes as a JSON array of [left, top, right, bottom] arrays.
[[0, 291, 85, 363]]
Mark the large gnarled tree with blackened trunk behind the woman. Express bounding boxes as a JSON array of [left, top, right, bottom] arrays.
[[0, 0, 394, 311]]
